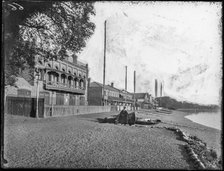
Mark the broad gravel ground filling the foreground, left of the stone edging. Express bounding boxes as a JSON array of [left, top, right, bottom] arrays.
[[4, 113, 190, 169]]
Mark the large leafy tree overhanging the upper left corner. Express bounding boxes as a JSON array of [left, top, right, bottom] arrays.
[[4, 1, 95, 84]]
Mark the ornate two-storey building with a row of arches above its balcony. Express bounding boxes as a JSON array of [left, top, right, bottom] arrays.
[[36, 55, 88, 105]]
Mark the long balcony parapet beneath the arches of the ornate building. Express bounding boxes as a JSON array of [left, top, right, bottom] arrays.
[[45, 81, 85, 95]]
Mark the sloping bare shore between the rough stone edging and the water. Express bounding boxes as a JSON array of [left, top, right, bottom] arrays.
[[136, 110, 222, 156]]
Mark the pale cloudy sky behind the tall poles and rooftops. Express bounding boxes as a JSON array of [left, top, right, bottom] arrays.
[[78, 1, 222, 104]]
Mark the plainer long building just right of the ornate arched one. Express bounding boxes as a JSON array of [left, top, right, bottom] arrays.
[[88, 82, 134, 110]]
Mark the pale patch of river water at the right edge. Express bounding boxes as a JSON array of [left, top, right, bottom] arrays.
[[185, 112, 222, 130]]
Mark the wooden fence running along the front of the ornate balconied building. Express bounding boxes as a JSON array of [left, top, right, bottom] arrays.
[[5, 96, 117, 118]]
